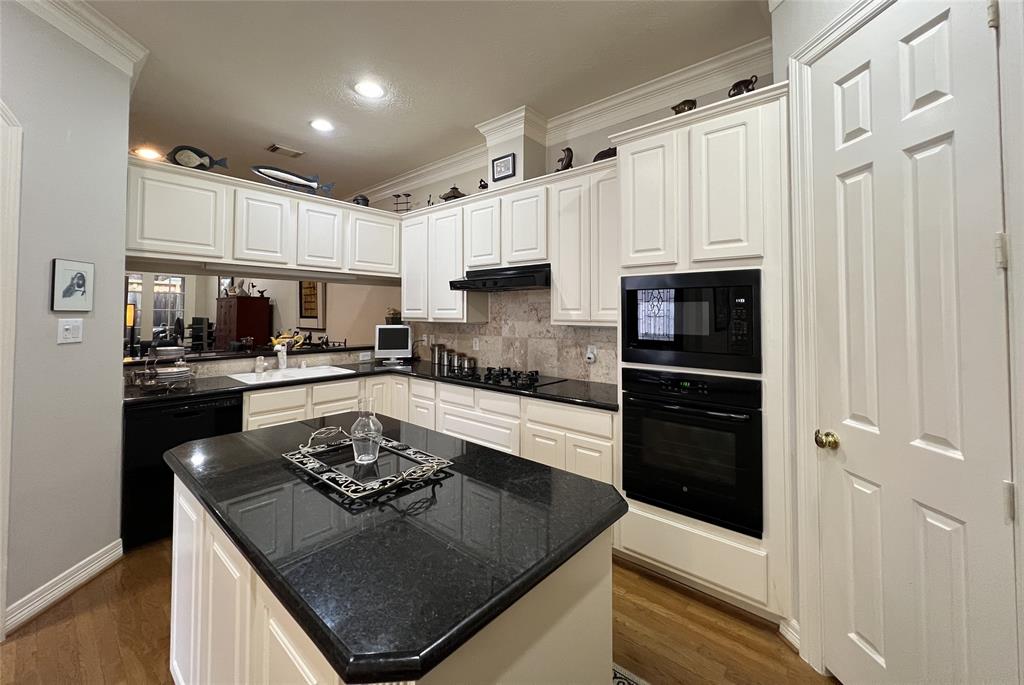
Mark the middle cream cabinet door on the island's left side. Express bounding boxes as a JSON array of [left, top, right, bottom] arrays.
[[199, 521, 252, 683]]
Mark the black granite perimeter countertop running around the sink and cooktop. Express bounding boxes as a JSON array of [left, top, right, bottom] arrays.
[[124, 361, 618, 412]]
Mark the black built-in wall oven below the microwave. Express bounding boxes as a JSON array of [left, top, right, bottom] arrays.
[[623, 369, 764, 538]]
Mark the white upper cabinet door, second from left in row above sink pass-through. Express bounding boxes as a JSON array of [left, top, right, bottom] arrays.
[[234, 188, 296, 264]]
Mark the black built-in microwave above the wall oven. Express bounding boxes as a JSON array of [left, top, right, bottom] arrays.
[[622, 269, 761, 373]]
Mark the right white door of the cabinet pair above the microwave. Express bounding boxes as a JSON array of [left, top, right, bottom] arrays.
[[680, 108, 765, 261]]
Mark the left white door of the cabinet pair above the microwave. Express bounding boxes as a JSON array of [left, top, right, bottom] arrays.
[[618, 131, 685, 266]]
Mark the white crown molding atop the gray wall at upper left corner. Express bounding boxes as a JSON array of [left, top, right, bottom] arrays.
[[17, 0, 150, 88]]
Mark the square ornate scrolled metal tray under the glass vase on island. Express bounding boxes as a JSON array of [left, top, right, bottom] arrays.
[[282, 428, 452, 500]]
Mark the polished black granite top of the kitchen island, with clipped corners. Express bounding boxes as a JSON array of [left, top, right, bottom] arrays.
[[164, 413, 627, 683]]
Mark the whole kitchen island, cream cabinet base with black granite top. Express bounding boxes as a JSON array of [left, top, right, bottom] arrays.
[[165, 414, 627, 685]]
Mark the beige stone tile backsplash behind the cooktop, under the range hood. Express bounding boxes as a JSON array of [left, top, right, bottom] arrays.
[[413, 290, 617, 383]]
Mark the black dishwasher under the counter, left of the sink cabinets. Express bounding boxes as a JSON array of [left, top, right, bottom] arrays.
[[121, 393, 242, 550]]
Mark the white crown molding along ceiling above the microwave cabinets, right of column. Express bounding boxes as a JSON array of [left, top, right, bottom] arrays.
[[548, 38, 772, 147]]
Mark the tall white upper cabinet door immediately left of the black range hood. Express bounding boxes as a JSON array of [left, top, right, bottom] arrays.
[[428, 207, 466, 320]]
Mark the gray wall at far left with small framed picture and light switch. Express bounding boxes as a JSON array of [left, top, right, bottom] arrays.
[[0, 2, 129, 602]]
